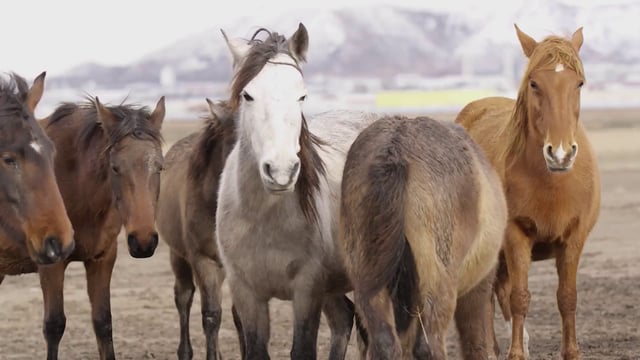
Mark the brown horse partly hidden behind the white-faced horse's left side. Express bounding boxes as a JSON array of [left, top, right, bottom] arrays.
[[157, 99, 235, 359]]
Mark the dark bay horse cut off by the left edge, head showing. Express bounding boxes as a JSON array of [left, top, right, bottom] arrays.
[[0, 72, 75, 283]]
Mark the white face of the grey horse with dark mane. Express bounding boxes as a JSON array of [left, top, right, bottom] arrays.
[[240, 54, 306, 186]]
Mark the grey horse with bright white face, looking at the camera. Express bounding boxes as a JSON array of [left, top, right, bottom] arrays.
[[215, 23, 382, 359]]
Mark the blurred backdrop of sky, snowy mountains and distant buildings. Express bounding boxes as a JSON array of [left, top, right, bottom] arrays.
[[0, 0, 640, 121]]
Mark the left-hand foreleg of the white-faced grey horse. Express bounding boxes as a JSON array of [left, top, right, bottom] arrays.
[[229, 279, 270, 360]]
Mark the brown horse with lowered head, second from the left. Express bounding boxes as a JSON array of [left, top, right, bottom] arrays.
[[39, 97, 165, 359]]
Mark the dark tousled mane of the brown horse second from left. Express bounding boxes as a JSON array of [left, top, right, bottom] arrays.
[[49, 98, 163, 150]]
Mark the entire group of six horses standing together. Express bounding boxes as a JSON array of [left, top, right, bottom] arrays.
[[0, 24, 600, 359]]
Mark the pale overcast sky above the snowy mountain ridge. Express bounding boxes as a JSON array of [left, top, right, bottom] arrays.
[[0, 0, 632, 79]]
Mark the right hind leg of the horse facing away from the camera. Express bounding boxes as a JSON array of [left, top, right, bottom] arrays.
[[455, 271, 495, 360]]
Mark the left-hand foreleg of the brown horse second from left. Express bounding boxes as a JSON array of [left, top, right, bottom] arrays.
[[38, 263, 67, 360]]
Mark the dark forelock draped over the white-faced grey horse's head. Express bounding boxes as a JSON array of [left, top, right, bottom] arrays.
[[229, 28, 302, 112]]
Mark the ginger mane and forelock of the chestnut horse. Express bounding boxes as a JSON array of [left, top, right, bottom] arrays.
[[497, 35, 584, 167]]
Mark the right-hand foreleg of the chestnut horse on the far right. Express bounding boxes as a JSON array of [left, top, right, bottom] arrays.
[[556, 236, 586, 360]]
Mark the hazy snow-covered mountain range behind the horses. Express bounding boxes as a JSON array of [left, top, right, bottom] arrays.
[[51, 0, 640, 87]]
